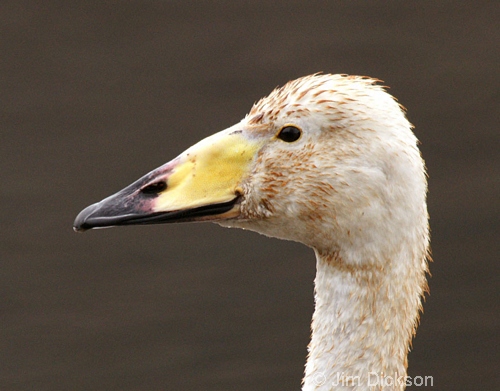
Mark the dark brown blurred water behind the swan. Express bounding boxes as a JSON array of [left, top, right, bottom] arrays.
[[0, 0, 500, 391]]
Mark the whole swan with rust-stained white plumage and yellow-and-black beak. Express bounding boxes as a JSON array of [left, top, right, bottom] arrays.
[[74, 74, 429, 391]]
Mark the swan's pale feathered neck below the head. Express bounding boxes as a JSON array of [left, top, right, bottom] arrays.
[[303, 251, 425, 391]]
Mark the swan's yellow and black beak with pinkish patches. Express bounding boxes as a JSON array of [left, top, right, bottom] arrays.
[[74, 127, 262, 231]]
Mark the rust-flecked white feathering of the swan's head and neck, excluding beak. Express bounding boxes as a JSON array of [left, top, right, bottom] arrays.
[[222, 75, 429, 391]]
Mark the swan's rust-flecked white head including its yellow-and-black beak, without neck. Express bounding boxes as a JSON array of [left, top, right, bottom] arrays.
[[74, 75, 427, 262]]
